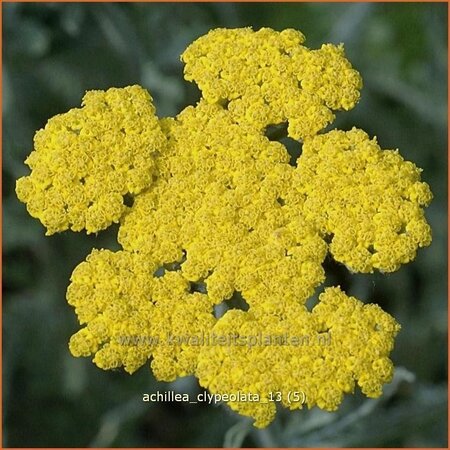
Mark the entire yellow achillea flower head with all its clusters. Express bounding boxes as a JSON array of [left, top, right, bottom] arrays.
[[17, 28, 432, 427]]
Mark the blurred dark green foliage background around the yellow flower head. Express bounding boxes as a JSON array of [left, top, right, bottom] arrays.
[[2, 3, 447, 447]]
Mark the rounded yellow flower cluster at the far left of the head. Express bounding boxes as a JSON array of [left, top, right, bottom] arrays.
[[16, 86, 165, 235]]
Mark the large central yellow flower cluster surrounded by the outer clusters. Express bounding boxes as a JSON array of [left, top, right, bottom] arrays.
[[119, 101, 327, 309]]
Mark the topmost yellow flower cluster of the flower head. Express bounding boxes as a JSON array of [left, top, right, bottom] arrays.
[[181, 28, 362, 139]]
